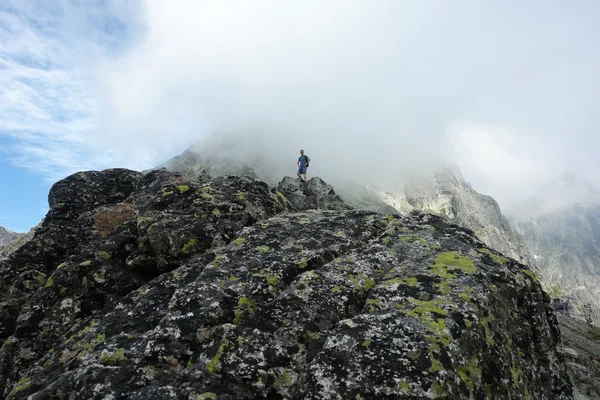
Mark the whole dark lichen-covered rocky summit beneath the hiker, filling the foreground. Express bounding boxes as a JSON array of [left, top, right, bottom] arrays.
[[0, 169, 573, 400]]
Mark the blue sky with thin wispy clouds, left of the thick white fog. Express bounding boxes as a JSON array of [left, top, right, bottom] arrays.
[[0, 0, 144, 232]]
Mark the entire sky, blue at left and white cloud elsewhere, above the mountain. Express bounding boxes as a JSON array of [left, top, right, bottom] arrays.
[[0, 0, 600, 231]]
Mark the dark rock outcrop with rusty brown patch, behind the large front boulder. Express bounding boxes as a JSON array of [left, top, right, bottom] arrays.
[[0, 170, 287, 396]]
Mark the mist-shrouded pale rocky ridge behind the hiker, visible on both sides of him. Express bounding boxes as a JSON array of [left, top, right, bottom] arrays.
[[161, 146, 535, 266]]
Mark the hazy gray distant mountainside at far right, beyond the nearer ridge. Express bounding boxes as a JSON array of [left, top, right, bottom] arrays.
[[515, 205, 600, 324]]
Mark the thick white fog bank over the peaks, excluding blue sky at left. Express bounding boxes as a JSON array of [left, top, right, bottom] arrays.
[[1, 0, 600, 217]]
